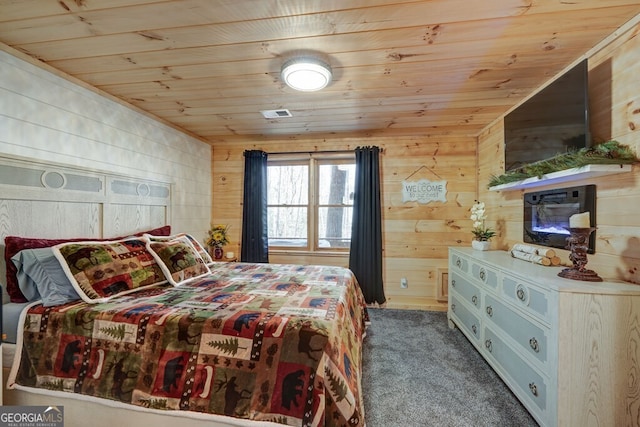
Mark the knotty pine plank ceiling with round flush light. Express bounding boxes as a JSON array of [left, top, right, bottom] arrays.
[[0, 0, 640, 143]]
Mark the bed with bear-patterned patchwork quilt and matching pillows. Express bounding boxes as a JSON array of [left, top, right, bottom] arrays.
[[0, 155, 367, 426]]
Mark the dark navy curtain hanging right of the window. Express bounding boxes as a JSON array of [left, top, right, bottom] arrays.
[[349, 147, 386, 304]]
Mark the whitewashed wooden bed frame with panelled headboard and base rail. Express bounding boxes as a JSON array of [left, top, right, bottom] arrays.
[[0, 156, 280, 427]]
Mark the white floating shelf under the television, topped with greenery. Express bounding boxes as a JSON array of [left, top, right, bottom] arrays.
[[489, 164, 631, 191]]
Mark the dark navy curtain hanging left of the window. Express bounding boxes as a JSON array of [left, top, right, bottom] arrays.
[[240, 150, 269, 263]]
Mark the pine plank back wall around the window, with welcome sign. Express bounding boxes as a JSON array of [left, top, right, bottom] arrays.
[[212, 135, 476, 310]]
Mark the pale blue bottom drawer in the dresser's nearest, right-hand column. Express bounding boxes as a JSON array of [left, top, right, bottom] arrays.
[[483, 327, 549, 419]]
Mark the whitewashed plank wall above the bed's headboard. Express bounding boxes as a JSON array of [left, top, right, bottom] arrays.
[[0, 45, 211, 246]]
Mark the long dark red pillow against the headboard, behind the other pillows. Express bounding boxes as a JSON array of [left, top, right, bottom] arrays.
[[4, 225, 171, 302]]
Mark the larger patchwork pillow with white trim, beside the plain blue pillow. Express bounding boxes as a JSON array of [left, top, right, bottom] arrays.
[[53, 238, 166, 303]]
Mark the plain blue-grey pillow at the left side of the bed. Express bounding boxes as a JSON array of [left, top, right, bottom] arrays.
[[11, 248, 80, 307]]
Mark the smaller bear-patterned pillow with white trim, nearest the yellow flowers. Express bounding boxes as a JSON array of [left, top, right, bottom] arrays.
[[147, 236, 211, 286]]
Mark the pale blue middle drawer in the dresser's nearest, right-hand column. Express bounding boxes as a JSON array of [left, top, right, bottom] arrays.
[[484, 295, 549, 367]]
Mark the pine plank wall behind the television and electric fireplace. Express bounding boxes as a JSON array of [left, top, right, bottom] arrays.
[[478, 20, 640, 284]]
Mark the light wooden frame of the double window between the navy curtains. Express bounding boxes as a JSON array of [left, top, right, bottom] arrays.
[[267, 151, 356, 254]]
